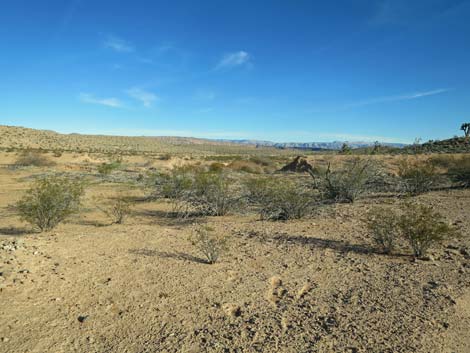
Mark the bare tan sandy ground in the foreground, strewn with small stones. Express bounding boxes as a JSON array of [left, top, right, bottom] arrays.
[[0, 157, 470, 353]]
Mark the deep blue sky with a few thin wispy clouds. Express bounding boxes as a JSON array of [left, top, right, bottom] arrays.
[[0, 0, 470, 142]]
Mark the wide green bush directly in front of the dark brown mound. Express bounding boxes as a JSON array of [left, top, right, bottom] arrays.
[[245, 178, 315, 221]]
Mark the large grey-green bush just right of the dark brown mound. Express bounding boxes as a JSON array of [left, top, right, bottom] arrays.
[[316, 158, 378, 202]]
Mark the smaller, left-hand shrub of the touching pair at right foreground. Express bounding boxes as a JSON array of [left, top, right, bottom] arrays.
[[366, 208, 401, 254]]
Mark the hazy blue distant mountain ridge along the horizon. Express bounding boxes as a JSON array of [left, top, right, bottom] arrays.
[[216, 139, 407, 150]]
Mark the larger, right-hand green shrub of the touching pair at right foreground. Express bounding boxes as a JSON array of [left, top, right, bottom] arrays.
[[398, 203, 457, 257]]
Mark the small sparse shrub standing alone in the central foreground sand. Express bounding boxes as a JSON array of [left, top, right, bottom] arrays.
[[192, 226, 227, 264]]
